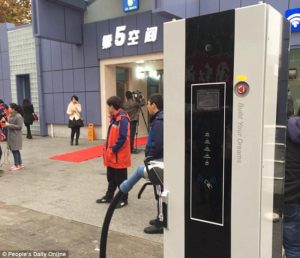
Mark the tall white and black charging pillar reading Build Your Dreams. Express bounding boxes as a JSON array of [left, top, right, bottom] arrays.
[[164, 4, 289, 258]]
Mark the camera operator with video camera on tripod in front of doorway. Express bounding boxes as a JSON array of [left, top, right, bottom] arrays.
[[124, 91, 145, 153]]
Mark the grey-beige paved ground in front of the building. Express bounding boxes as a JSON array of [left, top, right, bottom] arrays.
[[0, 136, 163, 258]]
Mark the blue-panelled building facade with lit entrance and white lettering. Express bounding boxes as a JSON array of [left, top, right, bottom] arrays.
[[0, 0, 300, 138]]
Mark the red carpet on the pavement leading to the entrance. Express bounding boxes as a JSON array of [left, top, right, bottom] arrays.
[[50, 137, 147, 162]]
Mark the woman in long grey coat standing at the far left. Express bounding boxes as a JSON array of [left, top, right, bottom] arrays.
[[1, 103, 24, 171]]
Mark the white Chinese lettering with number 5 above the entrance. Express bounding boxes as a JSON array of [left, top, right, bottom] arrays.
[[101, 25, 158, 50]]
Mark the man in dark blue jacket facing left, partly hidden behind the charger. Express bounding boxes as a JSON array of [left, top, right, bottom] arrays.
[[131, 94, 164, 234]]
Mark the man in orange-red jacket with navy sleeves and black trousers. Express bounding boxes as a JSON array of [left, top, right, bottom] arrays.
[[96, 96, 131, 208]]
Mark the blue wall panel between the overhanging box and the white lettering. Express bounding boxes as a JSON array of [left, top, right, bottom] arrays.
[[83, 23, 98, 67]]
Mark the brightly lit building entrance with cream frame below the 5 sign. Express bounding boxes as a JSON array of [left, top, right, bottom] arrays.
[[100, 53, 163, 138]]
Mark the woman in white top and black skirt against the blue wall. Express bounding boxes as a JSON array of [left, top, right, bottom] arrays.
[[67, 95, 83, 145]]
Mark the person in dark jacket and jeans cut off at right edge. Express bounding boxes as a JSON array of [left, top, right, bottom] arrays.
[[283, 109, 300, 258]]
